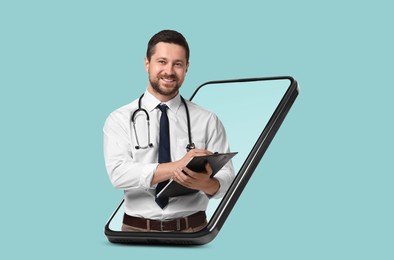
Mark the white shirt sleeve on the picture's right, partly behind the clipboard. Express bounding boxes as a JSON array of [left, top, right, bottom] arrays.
[[206, 114, 235, 199]]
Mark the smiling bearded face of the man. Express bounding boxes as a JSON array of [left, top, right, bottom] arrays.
[[145, 42, 189, 101]]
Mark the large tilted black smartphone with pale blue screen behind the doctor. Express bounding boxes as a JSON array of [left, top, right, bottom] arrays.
[[105, 76, 299, 245]]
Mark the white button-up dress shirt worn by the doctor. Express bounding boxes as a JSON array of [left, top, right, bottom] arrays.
[[103, 91, 234, 220]]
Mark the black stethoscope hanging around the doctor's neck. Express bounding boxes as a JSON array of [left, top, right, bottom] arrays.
[[130, 94, 196, 152]]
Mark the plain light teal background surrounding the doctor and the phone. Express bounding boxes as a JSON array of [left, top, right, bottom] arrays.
[[0, 1, 394, 259]]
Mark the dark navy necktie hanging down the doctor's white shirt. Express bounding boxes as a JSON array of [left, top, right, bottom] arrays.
[[156, 104, 171, 209]]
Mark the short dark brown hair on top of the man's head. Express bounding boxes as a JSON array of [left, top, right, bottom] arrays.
[[146, 30, 190, 63]]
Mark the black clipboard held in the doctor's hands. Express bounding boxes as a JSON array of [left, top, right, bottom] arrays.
[[156, 152, 238, 198]]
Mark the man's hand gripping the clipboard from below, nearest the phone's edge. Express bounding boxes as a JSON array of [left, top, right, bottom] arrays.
[[172, 163, 220, 196]]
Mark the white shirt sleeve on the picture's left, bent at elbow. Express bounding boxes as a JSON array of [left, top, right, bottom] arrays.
[[103, 112, 158, 190]]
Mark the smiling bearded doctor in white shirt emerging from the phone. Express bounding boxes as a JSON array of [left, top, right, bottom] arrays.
[[103, 30, 234, 232]]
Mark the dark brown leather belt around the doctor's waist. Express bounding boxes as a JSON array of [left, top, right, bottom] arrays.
[[123, 211, 207, 231]]
